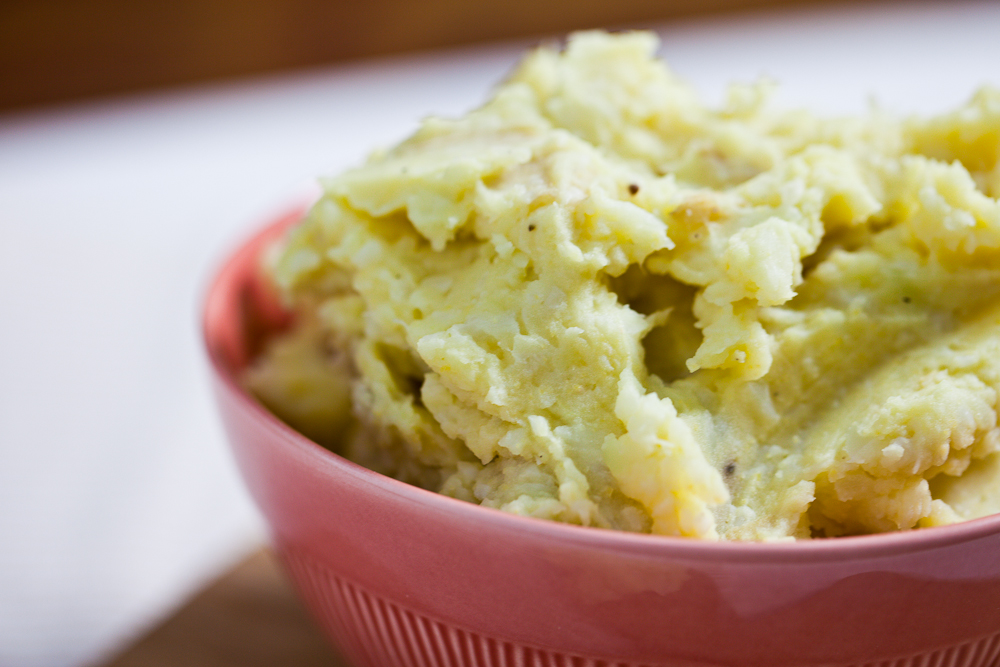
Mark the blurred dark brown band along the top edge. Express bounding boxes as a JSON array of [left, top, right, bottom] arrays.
[[0, 0, 860, 108]]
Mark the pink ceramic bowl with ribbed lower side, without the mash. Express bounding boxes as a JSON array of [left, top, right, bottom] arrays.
[[204, 214, 1000, 667]]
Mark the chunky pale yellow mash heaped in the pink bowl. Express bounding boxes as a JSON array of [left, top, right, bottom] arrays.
[[247, 33, 1000, 540]]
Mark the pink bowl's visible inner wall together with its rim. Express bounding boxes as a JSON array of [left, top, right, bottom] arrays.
[[203, 208, 1000, 562]]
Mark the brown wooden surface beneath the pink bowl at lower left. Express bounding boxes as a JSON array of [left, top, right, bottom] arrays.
[[105, 550, 348, 667]]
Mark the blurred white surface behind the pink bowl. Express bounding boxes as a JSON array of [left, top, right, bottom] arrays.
[[0, 3, 1000, 667]]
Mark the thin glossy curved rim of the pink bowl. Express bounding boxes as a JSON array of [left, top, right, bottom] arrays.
[[200, 211, 1000, 565]]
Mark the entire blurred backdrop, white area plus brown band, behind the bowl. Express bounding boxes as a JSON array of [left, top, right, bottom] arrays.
[[0, 0, 1000, 667]]
